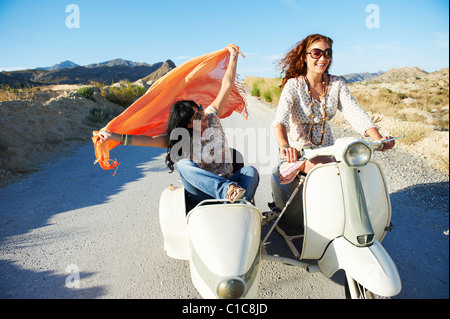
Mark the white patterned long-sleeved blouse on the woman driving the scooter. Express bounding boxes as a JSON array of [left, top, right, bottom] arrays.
[[272, 75, 375, 150]]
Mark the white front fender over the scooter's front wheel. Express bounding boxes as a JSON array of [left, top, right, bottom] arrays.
[[318, 237, 401, 297]]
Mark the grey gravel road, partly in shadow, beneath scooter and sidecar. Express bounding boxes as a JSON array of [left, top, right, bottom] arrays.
[[0, 97, 449, 299]]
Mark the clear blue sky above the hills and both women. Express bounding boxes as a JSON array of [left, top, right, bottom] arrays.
[[0, 0, 449, 77]]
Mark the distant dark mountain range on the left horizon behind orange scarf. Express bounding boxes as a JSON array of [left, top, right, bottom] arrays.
[[0, 59, 176, 87]]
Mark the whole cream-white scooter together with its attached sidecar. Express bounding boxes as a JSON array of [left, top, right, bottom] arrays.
[[160, 138, 401, 298]]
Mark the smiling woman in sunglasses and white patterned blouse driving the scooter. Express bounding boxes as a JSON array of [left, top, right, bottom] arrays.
[[272, 34, 395, 180]]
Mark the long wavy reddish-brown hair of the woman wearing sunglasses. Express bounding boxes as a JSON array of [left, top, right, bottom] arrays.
[[278, 34, 333, 87]]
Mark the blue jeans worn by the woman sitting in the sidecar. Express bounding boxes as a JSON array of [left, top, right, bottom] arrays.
[[177, 159, 259, 202]]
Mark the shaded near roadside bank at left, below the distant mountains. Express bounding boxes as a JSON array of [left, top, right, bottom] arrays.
[[0, 85, 123, 179]]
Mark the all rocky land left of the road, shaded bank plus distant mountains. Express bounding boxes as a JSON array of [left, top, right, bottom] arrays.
[[0, 59, 175, 188]]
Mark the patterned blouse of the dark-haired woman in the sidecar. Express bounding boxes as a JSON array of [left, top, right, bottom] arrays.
[[191, 106, 233, 177]]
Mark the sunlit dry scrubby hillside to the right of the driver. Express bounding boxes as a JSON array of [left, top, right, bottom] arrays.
[[342, 67, 449, 172]]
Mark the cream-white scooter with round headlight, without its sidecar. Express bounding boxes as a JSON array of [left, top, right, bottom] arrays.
[[263, 136, 403, 298]]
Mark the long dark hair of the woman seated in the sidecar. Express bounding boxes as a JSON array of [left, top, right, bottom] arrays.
[[165, 100, 198, 173]]
